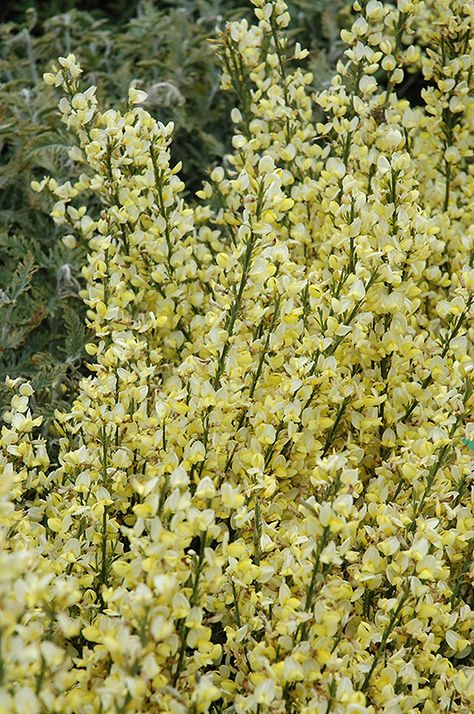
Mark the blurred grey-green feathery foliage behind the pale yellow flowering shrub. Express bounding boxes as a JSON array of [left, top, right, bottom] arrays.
[[0, 0, 350, 422]]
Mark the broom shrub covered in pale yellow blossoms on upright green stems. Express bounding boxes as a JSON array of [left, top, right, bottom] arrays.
[[0, 0, 474, 714]]
